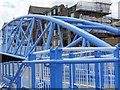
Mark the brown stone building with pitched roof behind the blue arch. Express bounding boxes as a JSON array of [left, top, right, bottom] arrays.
[[28, 4, 70, 46]]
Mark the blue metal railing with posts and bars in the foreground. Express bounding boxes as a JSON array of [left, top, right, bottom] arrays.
[[0, 47, 120, 89]]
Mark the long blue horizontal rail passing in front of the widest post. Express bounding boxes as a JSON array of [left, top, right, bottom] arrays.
[[22, 58, 119, 64]]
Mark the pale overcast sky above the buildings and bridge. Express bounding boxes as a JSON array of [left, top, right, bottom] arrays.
[[0, 0, 120, 29]]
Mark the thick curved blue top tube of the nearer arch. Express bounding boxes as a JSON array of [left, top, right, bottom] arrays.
[[2, 15, 112, 47]]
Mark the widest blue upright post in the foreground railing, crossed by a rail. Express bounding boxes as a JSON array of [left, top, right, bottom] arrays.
[[50, 48, 63, 88]]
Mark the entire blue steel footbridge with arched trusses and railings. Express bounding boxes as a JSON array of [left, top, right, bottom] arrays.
[[0, 15, 120, 90]]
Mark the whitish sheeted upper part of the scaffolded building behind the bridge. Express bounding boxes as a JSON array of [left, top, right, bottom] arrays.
[[76, 0, 111, 13]]
